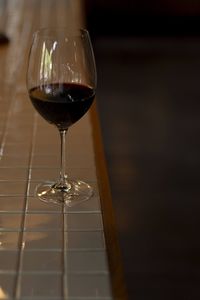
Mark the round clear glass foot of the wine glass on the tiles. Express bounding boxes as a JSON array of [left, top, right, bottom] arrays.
[[36, 180, 93, 207]]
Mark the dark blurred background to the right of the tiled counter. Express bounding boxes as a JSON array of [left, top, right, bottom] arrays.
[[85, 0, 200, 300]]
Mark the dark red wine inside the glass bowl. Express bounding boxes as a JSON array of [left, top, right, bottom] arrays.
[[29, 83, 95, 130]]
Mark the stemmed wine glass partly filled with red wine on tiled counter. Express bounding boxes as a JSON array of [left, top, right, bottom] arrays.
[[27, 28, 96, 206]]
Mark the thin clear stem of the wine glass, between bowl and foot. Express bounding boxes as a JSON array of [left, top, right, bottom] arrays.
[[59, 130, 67, 187]]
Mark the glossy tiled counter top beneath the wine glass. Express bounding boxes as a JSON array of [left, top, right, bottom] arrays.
[[0, 0, 112, 300]]
